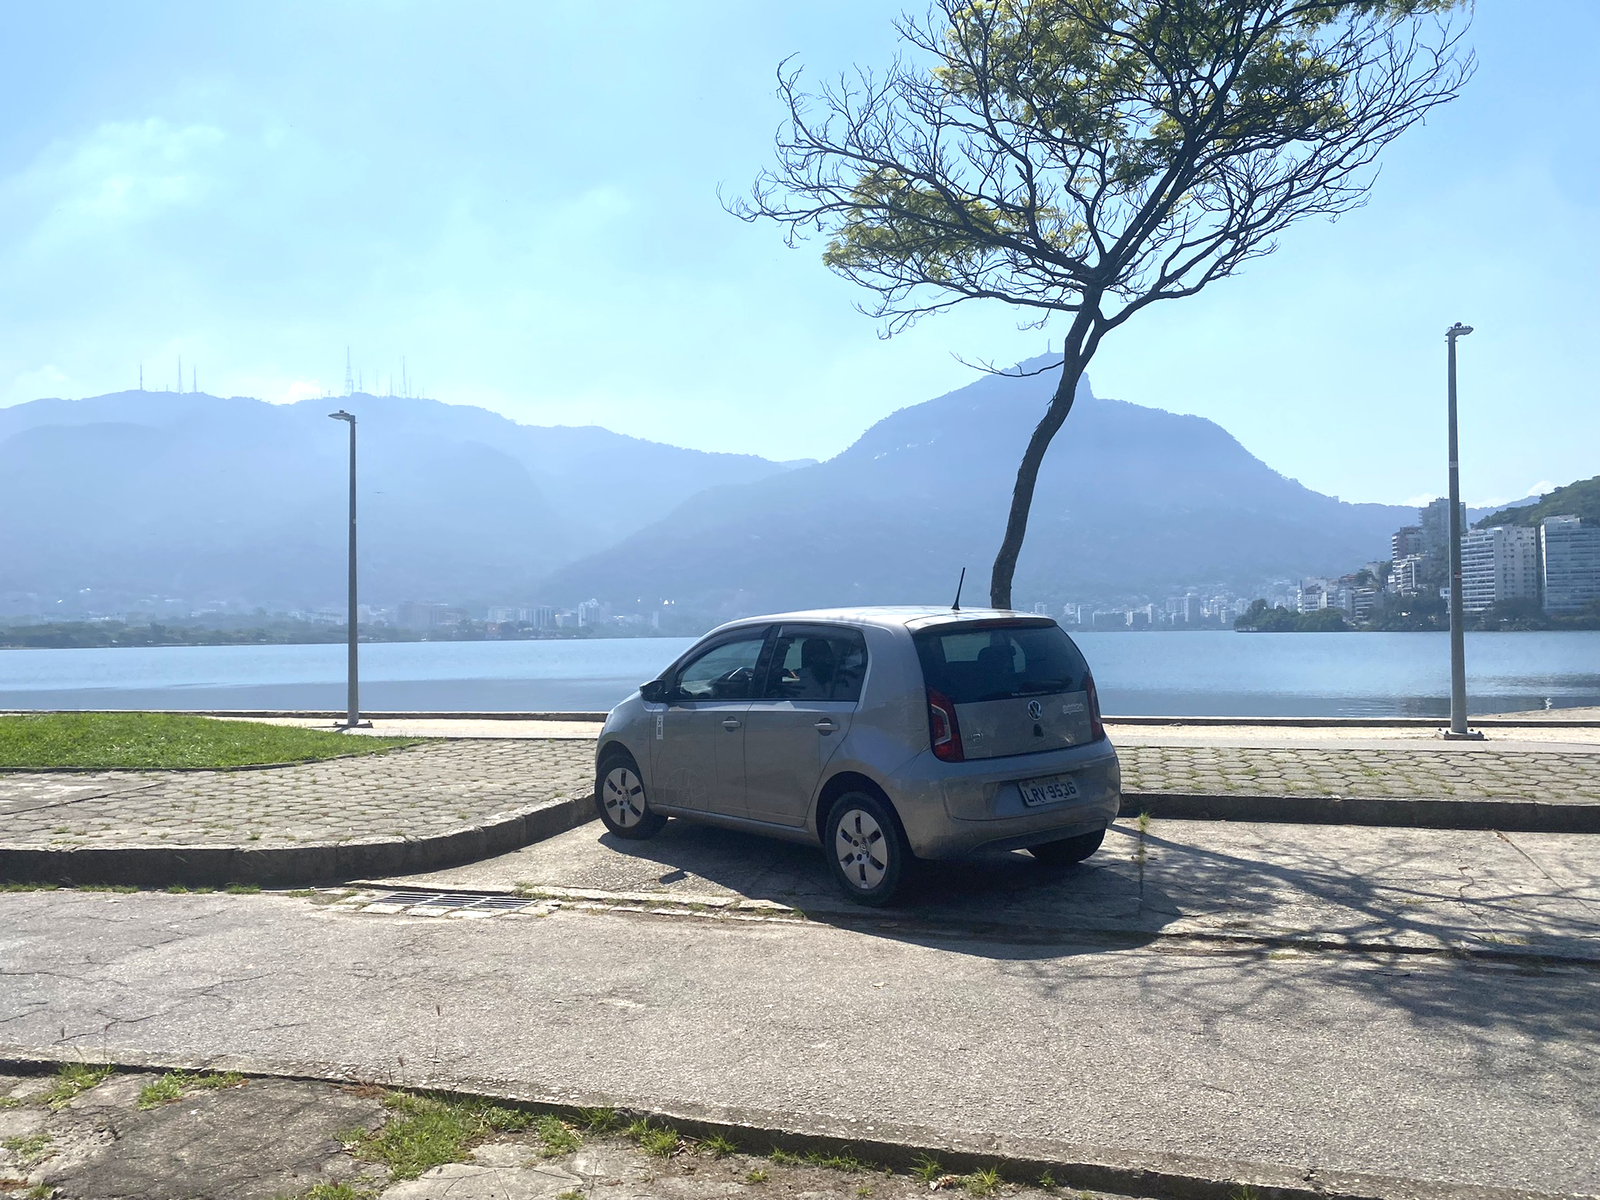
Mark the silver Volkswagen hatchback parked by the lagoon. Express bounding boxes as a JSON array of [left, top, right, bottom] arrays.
[[595, 608, 1122, 904]]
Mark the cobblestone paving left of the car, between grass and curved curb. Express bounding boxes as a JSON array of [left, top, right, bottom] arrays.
[[0, 739, 594, 848]]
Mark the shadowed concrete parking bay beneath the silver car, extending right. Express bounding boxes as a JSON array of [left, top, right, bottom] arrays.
[[368, 819, 1600, 965]]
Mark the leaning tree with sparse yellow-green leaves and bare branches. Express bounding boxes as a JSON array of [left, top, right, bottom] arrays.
[[730, 0, 1472, 608]]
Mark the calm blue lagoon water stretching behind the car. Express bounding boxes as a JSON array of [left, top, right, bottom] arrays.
[[0, 630, 1600, 717]]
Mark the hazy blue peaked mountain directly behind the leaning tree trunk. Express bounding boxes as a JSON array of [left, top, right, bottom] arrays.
[[542, 360, 1416, 613]]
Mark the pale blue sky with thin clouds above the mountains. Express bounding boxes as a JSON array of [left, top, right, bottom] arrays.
[[0, 0, 1600, 502]]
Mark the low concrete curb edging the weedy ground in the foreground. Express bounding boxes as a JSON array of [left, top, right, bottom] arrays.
[[0, 1043, 1557, 1200]]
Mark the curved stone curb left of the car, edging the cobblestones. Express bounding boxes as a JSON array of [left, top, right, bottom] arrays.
[[0, 795, 595, 888]]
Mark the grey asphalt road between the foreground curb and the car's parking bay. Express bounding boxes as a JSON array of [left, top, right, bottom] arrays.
[[0, 891, 1600, 1192]]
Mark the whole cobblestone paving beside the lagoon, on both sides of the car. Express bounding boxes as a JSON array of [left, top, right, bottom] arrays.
[[0, 738, 1600, 848]]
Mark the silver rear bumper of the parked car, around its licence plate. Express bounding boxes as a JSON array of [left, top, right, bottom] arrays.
[[893, 739, 1122, 858]]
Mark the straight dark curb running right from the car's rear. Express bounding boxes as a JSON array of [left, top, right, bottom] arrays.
[[1120, 792, 1600, 834]]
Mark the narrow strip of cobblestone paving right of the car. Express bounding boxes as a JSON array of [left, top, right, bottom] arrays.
[[1117, 746, 1600, 803]]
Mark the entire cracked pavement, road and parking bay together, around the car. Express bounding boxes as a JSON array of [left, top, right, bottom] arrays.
[[0, 821, 1600, 1194]]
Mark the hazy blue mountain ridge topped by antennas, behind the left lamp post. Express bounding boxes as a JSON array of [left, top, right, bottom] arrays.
[[0, 392, 800, 611]]
